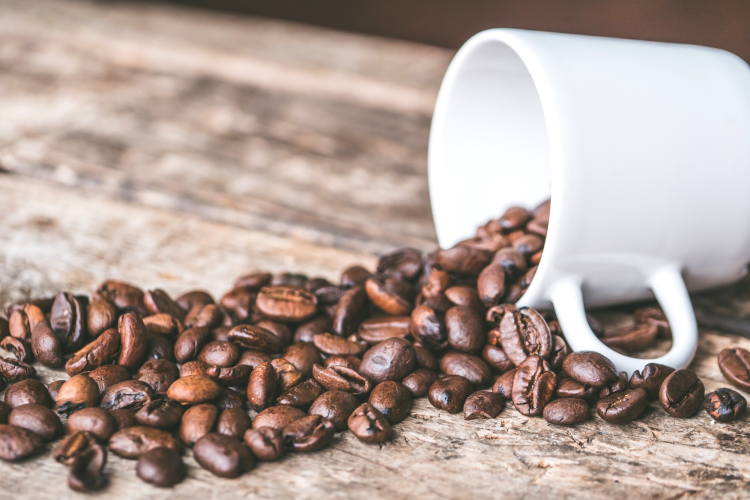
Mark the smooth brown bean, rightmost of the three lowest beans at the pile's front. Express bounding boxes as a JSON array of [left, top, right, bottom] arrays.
[[193, 432, 255, 479]]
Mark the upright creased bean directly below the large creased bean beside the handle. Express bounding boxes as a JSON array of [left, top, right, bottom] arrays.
[[512, 356, 557, 416]]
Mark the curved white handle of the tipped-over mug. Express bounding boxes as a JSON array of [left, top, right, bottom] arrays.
[[549, 264, 698, 377]]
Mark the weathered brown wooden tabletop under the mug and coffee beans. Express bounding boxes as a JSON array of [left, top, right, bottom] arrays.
[[0, 0, 750, 500]]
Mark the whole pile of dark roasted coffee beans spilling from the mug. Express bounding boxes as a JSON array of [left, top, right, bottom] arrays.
[[0, 202, 750, 491]]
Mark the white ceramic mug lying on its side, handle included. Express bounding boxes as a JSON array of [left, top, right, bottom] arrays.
[[429, 29, 750, 373]]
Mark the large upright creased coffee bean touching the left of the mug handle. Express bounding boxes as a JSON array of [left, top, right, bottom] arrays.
[[500, 307, 552, 366]]
